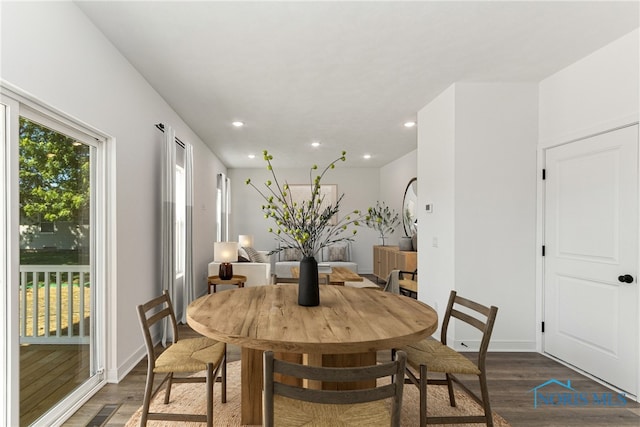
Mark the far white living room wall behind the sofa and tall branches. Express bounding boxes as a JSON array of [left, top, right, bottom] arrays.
[[229, 167, 379, 274]]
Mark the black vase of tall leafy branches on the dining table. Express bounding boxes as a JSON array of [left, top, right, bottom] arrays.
[[246, 150, 364, 306]]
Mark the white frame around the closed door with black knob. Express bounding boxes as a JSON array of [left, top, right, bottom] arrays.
[[535, 123, 640, 401]]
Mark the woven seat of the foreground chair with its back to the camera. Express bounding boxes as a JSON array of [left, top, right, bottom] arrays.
[[273, 396, 391, 427]]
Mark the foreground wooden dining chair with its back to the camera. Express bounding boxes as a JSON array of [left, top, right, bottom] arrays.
[[263, 351, 406, 427]]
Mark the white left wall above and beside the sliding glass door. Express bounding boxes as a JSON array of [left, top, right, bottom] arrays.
[[0, 2, 225, 380]]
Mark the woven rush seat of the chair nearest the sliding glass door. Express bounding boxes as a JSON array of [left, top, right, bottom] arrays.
[[153, 337, 225, 373]]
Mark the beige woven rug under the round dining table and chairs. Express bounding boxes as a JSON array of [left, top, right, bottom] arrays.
[[126, 362, 510, 427]]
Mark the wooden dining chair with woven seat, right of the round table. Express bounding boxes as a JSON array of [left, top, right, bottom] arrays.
[[401, 291, 498, 427]]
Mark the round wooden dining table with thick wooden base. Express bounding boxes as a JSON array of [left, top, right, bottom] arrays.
[[187, 284, 438, 424]]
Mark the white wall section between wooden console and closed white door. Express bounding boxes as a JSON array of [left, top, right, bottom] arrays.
[[418, 83, 537, 350]]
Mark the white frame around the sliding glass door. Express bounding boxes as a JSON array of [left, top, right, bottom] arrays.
[[0, 81, 117, 426]]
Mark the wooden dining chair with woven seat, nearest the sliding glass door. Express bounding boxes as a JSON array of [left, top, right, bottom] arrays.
[[138, 290, 227, 427]]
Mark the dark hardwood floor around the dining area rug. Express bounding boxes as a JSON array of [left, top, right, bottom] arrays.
[[64, 326, 640, 427]]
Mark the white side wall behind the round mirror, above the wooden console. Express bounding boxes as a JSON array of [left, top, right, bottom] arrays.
[[379, 150, 420, 245]]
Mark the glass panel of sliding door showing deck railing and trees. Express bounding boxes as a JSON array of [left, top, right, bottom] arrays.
[[18, 117, 96, 426]]
